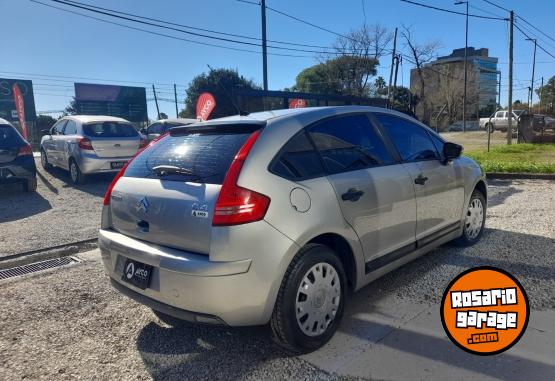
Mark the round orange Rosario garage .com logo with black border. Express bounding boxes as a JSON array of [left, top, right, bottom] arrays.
[[441, 266, 530, 356]]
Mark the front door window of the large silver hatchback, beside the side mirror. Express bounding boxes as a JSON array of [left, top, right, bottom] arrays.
[[375, 114, 439, 162]]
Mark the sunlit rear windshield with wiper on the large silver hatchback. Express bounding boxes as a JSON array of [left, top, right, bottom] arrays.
[[124, 132, 250, 184]]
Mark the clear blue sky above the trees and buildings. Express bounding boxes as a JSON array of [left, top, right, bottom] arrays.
[[0, 0, 555, 118]]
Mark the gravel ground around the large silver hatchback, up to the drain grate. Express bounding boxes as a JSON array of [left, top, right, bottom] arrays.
[[0, 180, 555, 380]]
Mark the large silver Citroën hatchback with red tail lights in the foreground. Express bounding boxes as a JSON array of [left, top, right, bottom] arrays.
[[99, 106, 486, 352]]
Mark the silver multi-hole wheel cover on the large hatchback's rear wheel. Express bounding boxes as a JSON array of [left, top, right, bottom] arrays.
[[295, 262, 341, 336]]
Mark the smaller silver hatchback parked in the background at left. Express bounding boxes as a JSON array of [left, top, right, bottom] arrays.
[[40, 115, 147, 184]]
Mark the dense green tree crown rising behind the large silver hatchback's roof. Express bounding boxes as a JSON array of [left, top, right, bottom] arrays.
[[294, 56, 378, 97]]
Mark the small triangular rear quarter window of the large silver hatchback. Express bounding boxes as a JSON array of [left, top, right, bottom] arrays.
[[270, 131, 324, 180]]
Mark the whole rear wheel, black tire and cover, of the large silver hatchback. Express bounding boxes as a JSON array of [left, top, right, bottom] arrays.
[[270, 244, 347, 354]]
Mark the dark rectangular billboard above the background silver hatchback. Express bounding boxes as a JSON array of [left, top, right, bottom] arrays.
[[75, 83, 148, 122]]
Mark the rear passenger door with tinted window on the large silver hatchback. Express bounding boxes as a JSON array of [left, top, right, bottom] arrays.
[[307, 114, 416, 264]]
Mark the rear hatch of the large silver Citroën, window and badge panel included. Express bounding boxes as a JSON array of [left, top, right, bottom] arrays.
[[110, 124, 261, 254]]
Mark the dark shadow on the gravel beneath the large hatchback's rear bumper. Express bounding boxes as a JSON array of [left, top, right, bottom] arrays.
[[137, 322, 284, 380]]
